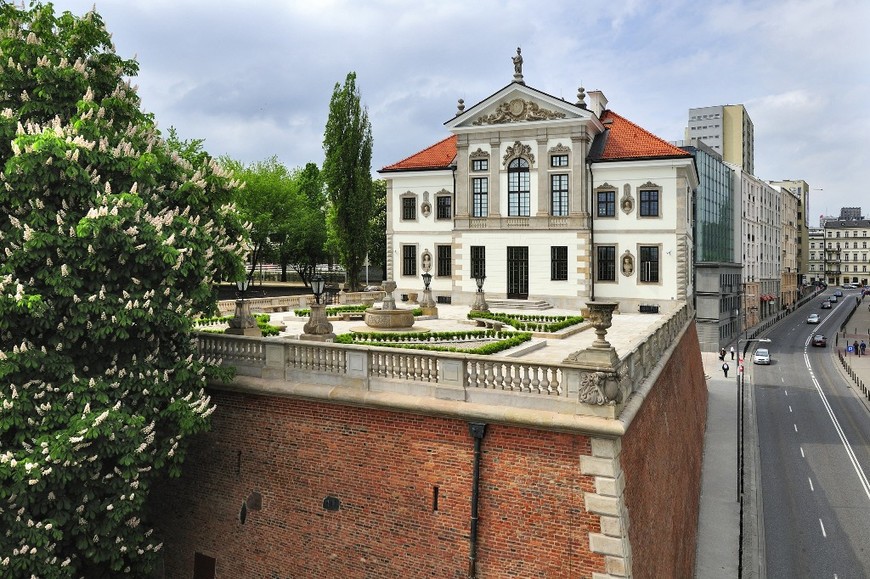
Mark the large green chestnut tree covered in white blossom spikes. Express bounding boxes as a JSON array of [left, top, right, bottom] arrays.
[[0, 2, 244, 577]]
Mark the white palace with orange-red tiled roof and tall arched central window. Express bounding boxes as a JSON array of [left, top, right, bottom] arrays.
[[381, 82, 697, 312]]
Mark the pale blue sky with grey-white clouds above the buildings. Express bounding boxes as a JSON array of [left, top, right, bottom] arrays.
[[54, 0, 870, 226]]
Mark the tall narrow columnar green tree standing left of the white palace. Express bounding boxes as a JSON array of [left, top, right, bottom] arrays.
[[323, 72, 372, 288]]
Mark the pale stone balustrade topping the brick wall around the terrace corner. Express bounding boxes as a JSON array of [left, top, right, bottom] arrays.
[[196, 305, 692, 418]]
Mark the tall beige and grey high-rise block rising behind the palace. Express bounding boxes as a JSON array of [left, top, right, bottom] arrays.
[[686, 105, 755, 175]]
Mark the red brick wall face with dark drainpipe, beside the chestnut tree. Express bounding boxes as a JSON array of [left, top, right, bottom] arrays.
[[153, 391, 604, 579]]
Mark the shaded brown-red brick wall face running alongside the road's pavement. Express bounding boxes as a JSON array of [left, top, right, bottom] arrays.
[[621, 324, 707, 579]]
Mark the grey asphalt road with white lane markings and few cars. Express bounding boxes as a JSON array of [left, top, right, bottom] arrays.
[[747, 288, 870, 579]]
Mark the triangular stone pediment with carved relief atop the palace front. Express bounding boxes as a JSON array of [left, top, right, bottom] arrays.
[[444, 82, 598, 131]]
